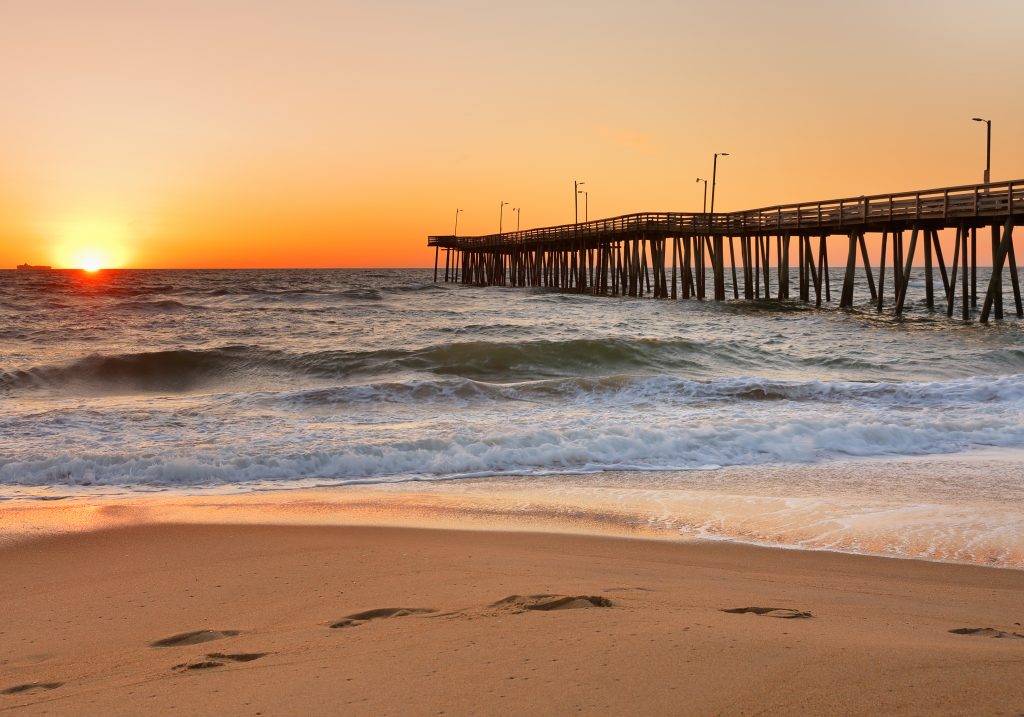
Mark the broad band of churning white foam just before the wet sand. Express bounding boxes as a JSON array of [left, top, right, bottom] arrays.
[[0, 391, 1024, 486]]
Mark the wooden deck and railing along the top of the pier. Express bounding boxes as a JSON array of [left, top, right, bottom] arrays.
[[427, 179, 1024, 249]]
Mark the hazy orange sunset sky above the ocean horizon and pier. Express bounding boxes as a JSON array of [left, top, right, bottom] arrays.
[[0, 0, 1024, 267]]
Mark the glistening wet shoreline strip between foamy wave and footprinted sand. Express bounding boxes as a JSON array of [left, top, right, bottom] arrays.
[[0, 451, 1024, 571]]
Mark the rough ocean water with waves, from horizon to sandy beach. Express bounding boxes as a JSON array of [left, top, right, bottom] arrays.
[[0, 269, 1024, 568]]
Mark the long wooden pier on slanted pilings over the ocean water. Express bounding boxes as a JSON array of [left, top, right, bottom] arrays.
[[428, 179, 1024, 322]]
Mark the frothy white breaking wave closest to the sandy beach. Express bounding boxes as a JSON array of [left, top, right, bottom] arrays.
[[0, 403, 1024, 487]]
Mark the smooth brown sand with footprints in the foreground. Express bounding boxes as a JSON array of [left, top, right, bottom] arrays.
[[0, 524, 1024, 716]]
